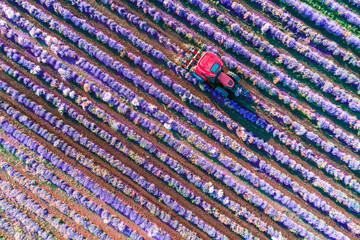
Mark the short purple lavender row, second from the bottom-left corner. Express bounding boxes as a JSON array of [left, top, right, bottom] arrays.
[[0, 196, 56, 240]]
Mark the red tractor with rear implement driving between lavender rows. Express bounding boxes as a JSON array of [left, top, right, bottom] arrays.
[[181, 48, 246, 97]]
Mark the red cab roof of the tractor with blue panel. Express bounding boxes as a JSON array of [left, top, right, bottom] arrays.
[[197, 52, 224, 77]]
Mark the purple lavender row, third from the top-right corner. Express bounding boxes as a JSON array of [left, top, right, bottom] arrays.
[[243, 0, 360, 73]]
